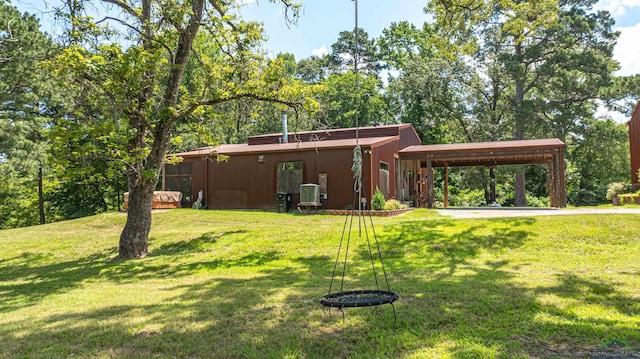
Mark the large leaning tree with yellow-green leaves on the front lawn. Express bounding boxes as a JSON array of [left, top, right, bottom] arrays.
[[51, 0, 312, 258]]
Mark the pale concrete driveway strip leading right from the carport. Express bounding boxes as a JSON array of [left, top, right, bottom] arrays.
[[438, 207, 640, 218]]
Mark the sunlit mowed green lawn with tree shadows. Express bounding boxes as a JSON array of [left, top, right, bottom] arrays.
[[0, 209, 640, 358]]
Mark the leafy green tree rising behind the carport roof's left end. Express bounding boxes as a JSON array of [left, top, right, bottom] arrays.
[[377, 22, 472, 143]]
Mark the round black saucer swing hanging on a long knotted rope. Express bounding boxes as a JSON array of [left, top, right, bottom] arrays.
[[320, 0, 400, 321]]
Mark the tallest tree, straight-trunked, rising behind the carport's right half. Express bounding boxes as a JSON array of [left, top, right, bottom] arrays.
[[428, 0, 617, 206]]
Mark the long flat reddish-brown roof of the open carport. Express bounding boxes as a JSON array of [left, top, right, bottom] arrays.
[[399, 138, 564, 167]]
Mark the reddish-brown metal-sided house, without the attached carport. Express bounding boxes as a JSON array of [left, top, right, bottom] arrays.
[[162, 124, 421, 210]]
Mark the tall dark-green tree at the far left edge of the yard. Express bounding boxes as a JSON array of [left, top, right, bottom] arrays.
[[0, 2, 58, 228]]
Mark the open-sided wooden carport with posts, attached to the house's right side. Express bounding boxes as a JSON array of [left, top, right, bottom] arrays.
[[399, 138, 567, 208]]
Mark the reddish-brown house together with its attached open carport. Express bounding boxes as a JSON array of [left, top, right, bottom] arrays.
[[162, 124, 564, 210]]
